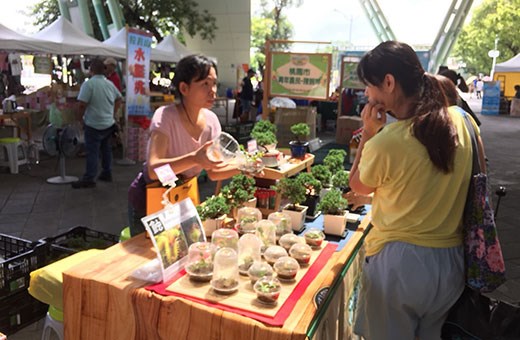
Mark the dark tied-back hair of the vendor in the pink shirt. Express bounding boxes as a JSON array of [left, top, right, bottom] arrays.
[[172, 54, 218, 101]]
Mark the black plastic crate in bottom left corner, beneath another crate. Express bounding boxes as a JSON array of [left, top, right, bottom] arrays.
[[0, 290, 49, 335]]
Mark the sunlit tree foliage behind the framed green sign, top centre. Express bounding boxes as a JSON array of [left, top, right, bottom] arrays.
[[251, 0, 303, 73]]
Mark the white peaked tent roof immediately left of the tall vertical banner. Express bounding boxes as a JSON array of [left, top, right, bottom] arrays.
[[32, 17, 126, 58]]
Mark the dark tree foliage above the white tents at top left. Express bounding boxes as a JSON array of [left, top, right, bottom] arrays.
[[32, 0, 217, 42]]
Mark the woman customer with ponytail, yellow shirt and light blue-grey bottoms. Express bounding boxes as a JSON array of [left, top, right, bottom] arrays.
[[350, 41, 472, 340]]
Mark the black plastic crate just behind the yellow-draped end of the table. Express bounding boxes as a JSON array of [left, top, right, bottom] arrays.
[[40, 226, 119, 263]]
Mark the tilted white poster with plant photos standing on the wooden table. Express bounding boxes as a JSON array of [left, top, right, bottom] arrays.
[[141, 198, 206, 282]]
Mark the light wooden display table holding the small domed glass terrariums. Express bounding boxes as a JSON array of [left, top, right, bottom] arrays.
[[63, 219, 368, 340]]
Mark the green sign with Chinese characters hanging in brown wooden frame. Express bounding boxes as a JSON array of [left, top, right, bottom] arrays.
[[270, 52, 331, 99]]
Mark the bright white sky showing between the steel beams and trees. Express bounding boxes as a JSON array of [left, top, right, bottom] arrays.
[[0, 0, 482, 47]]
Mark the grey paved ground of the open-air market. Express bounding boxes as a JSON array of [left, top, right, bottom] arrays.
[[0, 99, 520, 340]]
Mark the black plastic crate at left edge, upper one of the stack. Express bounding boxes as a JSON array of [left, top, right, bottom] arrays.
[[0, 234, 46, 304]]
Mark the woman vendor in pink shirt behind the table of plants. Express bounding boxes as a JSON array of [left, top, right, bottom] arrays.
[[128, 55, 239, 236]]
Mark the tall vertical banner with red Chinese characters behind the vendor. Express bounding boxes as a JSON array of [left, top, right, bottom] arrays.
[[126, 28, 152, 116]]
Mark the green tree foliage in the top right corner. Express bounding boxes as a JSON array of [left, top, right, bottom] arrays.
[[453, 0, 520, 74]]
